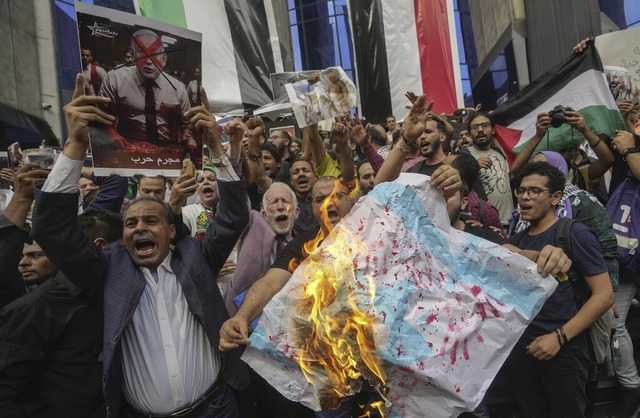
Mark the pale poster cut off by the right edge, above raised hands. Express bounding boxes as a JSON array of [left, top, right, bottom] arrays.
[[595, 28, 640, 103]]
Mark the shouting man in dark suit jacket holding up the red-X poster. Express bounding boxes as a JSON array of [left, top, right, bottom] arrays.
[[33, 76, 248, 418]]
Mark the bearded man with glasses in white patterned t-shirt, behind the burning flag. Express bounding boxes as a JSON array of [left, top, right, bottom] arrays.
[[461, 112, 513, 226]]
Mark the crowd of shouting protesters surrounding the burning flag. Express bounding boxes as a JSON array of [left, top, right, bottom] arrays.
[[0, 39, 640, 417]]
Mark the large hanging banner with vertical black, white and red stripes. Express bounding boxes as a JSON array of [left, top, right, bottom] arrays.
[[349, 0, 463, 123]]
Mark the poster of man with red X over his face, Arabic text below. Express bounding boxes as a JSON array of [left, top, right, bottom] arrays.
[[76, 3, 202, 176]]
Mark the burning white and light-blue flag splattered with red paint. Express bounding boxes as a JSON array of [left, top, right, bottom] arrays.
[[243, 175, 556, 417]]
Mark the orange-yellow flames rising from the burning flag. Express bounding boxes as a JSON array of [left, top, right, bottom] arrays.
[[289, 180, 386, 417]]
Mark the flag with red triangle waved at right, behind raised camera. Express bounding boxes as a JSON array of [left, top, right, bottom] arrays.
[[493, 43, 624, 165]]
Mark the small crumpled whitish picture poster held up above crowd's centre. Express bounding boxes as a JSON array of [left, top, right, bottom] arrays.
[[285, 67, 358, 128]]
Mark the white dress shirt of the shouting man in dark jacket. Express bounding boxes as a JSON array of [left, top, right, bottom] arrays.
[[42, 155, 238, 415]]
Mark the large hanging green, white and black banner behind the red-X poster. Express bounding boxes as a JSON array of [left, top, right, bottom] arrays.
[[134, 0, 292, 114]]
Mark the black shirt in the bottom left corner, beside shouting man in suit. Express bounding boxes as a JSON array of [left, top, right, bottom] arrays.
[[0, 275, 105, 418]]
